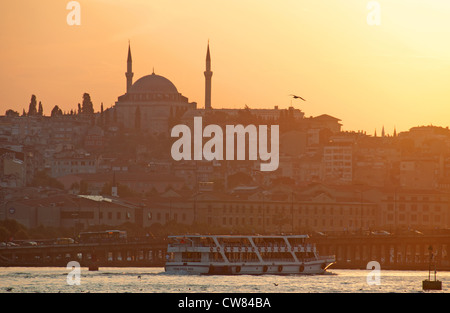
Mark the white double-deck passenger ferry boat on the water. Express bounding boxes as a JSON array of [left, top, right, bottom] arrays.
[[165, 235, 336, 275]]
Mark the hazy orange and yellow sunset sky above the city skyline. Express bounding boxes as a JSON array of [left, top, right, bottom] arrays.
[[0, 0, 450, 134]]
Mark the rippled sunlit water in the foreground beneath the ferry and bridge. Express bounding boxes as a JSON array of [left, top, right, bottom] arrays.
[[0, 267, 450, 293]]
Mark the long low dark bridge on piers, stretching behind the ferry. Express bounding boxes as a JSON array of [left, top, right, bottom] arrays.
[[0, 235, 450, 271]]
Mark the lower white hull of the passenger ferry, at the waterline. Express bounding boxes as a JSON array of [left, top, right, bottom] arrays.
[[165, 260, 333, 275]]
